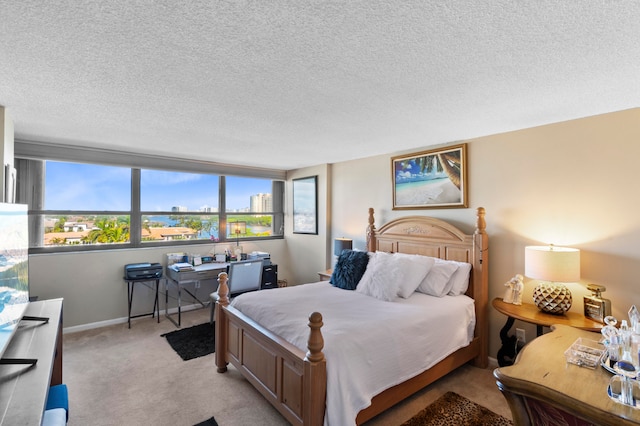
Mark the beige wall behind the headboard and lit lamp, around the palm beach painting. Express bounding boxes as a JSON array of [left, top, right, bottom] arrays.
[[331, 109, 640, 357]]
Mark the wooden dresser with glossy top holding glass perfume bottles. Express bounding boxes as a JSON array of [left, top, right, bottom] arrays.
[[493, 325, 640, 425]]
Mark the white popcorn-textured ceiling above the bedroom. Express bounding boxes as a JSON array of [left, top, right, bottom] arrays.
[[0, 0, 640, 170]]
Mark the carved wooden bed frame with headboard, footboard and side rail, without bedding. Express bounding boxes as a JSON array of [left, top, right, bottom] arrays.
[[215, 207, 488, 426]]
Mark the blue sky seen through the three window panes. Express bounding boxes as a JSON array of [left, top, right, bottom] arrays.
[[45, 161, 271, 211]]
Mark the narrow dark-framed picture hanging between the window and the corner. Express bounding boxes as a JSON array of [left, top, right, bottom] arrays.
[[293, 176, 318, 234]]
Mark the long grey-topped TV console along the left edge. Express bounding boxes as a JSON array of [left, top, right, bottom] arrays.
[[0, 299, 62, 425]]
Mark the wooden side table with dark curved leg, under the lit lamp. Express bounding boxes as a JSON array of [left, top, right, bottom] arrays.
[[491, 297, 602, 367]]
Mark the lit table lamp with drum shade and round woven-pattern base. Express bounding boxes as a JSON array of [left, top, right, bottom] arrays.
[[524, 244, 580, 315]]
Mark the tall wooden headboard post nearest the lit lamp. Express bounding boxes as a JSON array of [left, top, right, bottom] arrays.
[[473, 207, 489, 368]]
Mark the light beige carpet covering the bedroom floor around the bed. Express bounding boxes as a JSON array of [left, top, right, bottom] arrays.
[[63, 309, 511, 426]]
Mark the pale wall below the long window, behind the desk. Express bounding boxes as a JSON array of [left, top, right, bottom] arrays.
[[29, 240, 291, 328]]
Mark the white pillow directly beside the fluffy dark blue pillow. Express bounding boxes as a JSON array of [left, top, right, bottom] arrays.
[[355, 252, 401, 302]]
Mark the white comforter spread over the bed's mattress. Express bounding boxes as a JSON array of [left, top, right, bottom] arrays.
[[231, 281, 475, 425]]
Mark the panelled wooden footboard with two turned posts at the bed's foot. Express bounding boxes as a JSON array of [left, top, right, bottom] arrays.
[[215, 272, 327, 425]]
